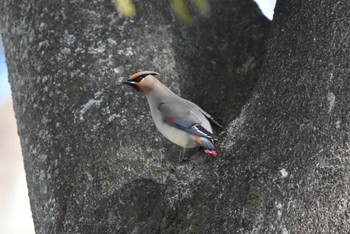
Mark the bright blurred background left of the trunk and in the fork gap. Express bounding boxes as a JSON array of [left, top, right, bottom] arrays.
[[0, 0, 276, 234]]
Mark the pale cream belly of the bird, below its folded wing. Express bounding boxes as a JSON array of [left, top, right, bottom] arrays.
[[157, 123, 199, 148]]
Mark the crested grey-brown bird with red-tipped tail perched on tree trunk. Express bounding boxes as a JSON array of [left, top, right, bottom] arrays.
[[122, 71, 222, 162]]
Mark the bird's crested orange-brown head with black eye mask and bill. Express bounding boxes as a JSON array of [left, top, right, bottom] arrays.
[[123, 71, 159, 93]]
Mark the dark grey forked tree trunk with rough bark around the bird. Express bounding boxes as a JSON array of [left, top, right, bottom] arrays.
[[0, 0, 350, 233]]
